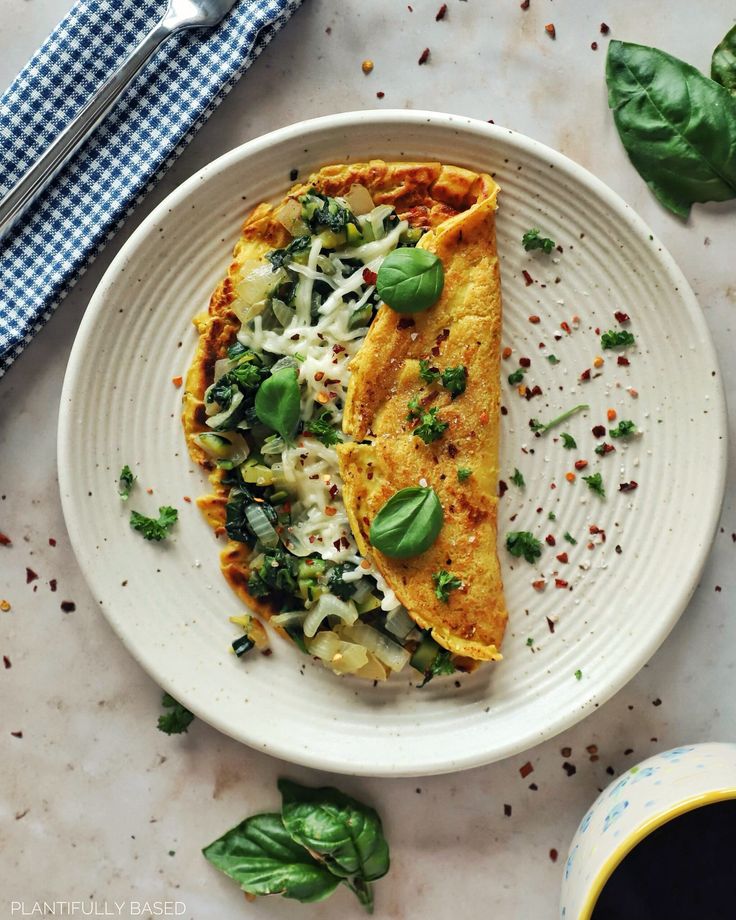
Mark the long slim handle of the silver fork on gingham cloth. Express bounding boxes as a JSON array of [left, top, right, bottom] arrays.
[[0, 17, 177, 241]]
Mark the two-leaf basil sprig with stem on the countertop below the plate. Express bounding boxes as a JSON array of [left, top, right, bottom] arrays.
[[202, 779, 390, 913]]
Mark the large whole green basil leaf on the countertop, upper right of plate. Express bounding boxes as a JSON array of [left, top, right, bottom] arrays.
[[606, 41, 736, 217]]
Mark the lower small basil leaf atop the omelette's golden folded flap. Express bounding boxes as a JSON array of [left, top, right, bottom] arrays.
[[370, 486, 444, 559]]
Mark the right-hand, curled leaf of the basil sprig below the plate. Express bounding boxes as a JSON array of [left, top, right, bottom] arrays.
[[278, 779, 389, 882]]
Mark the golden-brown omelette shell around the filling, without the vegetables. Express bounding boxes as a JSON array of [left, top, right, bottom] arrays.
[[182, 160, 507, 659]]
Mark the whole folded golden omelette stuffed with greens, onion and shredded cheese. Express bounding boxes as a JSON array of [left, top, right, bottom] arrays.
[[183, 160, 507, 683]]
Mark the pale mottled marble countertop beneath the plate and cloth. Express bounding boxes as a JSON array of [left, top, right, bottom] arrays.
[[0, 0, 736, 920]]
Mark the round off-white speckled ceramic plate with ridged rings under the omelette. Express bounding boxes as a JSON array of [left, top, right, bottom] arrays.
[[59, 111, 726, 775]]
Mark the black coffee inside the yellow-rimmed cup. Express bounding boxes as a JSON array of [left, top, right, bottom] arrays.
[[592, 800, 736, 920]]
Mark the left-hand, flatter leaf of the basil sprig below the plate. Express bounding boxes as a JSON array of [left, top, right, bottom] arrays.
[[202, 814, 340, 903]]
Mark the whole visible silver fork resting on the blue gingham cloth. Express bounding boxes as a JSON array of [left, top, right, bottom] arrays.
[[0, 0, 249, 240]]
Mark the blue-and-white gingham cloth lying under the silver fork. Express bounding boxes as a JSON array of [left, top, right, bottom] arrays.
[[0, 0, 302, 377]]
